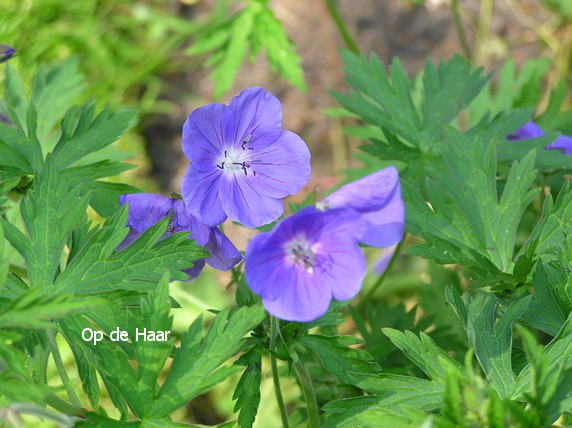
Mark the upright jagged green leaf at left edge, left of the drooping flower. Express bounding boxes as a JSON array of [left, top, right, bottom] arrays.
[[2, 156, 89, 287]]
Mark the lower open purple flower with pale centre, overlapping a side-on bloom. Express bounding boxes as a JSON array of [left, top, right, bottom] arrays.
[[244, 207, 366, 322]]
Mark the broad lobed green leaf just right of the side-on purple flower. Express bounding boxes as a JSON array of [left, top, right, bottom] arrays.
[[405, 129, 539, 272]]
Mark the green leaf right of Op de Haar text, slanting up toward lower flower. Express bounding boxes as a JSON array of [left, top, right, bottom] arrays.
[[148, 305, 266, 418]]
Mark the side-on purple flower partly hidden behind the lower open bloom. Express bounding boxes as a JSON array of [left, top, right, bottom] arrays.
[[318, 166, 405, 248]]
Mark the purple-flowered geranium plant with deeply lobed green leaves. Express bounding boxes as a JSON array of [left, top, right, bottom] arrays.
[[0, 49, 572, 428]]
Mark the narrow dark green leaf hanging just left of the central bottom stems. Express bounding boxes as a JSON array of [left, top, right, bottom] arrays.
[[232, 346, 264, 428]]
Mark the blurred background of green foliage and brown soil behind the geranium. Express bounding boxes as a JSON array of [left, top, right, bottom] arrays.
[[0, 0, 572, 428]]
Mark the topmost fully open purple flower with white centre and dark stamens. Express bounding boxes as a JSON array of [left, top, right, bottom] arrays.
[[181, 87, 310, 227]]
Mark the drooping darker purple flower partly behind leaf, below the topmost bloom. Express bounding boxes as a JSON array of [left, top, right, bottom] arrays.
[[119, 193, 242, 279]]
